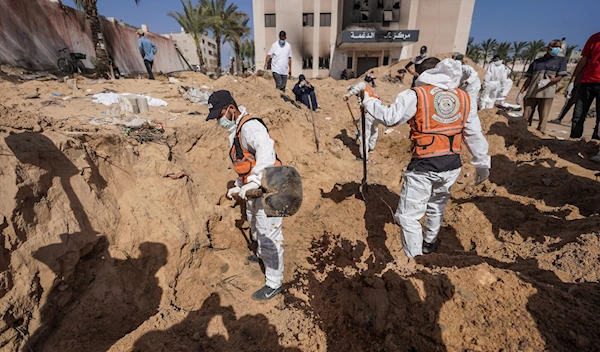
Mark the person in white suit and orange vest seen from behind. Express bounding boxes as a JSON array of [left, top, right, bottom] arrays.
[[346, 58, 491, 258]]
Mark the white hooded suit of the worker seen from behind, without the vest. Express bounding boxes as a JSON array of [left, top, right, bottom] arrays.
[[363, 59, 491, 257]]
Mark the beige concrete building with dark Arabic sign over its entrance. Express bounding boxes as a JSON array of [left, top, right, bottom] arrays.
[[252, 0, 475, 78]]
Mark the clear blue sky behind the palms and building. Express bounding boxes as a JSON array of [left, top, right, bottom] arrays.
[[68, 0, 600, 64]]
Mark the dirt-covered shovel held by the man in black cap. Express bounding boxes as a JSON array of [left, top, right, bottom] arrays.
[[233, 166, 302, 218]]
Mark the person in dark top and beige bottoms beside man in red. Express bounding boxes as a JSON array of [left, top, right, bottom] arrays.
[[517, 39, 568, 132]]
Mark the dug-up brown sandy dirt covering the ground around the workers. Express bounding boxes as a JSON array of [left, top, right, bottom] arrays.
[[0, 74, 600, 352]]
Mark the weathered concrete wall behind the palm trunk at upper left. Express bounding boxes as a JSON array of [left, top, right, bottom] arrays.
[[0, 0, 187, 73]]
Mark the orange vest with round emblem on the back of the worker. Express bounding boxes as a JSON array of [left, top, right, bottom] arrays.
[[409, 85, 471, 159]]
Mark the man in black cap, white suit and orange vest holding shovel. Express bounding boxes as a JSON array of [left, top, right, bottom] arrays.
[[206, 90, 283, 301]]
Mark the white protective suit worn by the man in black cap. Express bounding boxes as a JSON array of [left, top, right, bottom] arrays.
[[229, 106, 283, 289]]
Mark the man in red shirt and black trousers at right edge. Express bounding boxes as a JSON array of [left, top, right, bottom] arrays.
[[567, 32, 600, 139]]
